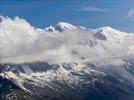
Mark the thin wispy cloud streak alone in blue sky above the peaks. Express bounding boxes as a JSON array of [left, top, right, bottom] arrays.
[[80, 7, 109, 12]]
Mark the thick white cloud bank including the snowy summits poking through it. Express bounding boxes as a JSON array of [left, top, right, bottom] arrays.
[[0, 17, 134, 63]]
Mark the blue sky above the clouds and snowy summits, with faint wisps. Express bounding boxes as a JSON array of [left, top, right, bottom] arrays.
[[0, 0, 134, 32]]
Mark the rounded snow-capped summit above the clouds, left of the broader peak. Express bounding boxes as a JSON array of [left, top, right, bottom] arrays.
[[55, 22, 77, 31]]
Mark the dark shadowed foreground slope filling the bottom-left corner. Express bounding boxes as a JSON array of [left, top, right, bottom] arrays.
[[0, 77, 45, 100]]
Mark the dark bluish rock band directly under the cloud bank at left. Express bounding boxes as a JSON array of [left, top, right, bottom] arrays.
[[0, 62, 55, 73]]
